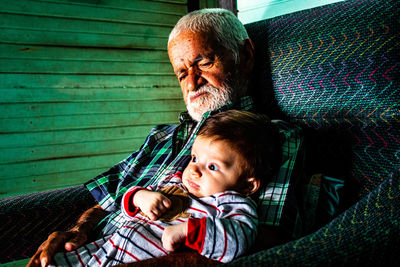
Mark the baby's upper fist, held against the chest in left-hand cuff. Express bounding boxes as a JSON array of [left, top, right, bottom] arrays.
[[133, 190, 171, 221]]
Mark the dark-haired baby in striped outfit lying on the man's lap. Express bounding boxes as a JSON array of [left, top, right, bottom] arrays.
[[51, 110, 281, 266]]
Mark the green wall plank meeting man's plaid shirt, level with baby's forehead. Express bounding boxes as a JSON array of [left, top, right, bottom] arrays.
[[0, 136, 145, 165]]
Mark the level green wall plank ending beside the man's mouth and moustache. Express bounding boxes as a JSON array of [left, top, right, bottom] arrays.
[[0, 87, 183, 103]]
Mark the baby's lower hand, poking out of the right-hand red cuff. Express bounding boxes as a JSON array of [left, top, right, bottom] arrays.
[[161, 222, 187, 251]]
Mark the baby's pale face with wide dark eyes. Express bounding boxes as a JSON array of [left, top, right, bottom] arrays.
[[182, 136, 243, 197]]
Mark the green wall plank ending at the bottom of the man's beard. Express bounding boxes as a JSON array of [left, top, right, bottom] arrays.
[[0, 111, 179, 133]]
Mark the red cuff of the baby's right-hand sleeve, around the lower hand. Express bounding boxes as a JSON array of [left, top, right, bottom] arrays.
[[185, 217, 206, 253]]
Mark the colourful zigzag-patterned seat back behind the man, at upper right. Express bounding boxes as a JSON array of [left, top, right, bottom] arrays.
[[247, 1, 400, 195]]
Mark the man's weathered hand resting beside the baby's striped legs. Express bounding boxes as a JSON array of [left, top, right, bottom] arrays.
[[27, 231, 87, 267]]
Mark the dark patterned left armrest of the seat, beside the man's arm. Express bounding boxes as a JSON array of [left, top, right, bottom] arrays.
[[0, 186, 95, 263]]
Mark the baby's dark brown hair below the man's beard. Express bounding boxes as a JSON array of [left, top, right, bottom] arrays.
[[198, 110, 282, 192]]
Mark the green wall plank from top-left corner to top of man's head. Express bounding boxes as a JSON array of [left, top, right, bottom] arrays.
[[0, 1, 184, 27]]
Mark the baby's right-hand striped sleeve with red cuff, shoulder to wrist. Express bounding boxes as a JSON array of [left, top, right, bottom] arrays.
[[185, 194, 258, 262]]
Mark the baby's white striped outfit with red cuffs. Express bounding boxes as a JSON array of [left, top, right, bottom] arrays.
[[55, 172, 258, 266]]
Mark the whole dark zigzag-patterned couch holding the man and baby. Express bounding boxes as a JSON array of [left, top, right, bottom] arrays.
[[0, 0, 400, 266]]
